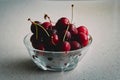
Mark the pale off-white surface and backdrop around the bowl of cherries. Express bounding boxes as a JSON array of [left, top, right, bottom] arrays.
[[0, 0, 120, 80]]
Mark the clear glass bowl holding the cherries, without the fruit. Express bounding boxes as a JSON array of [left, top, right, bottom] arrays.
[[23, 33, 92, 71]]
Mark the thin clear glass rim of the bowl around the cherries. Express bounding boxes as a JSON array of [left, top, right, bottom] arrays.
[[23, 33, 93, 53]]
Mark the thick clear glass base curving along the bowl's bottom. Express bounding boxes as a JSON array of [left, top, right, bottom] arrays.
[[33, 54, 79, 72]]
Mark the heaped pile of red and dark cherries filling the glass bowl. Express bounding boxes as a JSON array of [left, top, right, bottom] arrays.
[[28, 17, 89, 51]]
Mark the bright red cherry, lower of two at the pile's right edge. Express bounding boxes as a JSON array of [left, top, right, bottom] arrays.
[[78, 32, 89, 47]]
